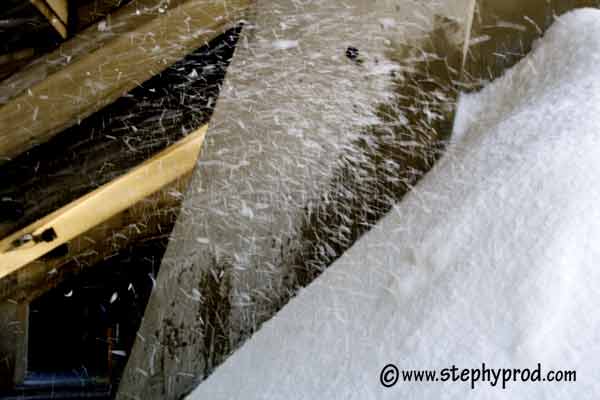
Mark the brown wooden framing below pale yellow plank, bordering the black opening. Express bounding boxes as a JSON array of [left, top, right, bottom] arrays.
[[0, 174, 191, 395]]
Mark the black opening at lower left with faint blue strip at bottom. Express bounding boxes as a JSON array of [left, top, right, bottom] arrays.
[[20, 239, 167, 398]]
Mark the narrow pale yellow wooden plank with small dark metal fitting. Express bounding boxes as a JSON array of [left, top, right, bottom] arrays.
[[0, 125, 207, 279]]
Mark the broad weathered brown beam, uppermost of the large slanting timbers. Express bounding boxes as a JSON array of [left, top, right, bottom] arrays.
[[0, 0, 252, 162]]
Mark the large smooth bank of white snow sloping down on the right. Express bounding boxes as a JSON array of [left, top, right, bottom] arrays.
[[189, 9, 600, 400]]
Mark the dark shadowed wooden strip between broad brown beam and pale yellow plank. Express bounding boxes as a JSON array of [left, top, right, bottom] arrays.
[[0, 29, 238, 238]]
